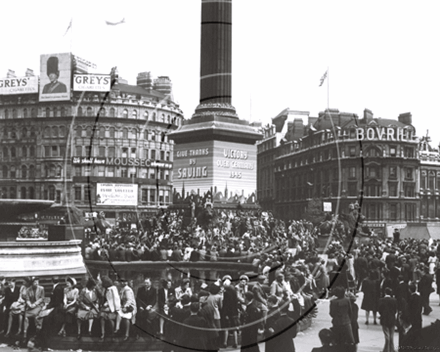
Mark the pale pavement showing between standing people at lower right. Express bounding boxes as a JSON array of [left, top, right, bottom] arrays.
[[0, 292, 440, 352]]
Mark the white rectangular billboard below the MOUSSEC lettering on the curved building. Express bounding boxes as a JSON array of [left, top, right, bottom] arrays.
[[96, 183, 138, 206]]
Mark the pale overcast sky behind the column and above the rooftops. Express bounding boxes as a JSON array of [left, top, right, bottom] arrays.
[[0, 0, 440, 145]]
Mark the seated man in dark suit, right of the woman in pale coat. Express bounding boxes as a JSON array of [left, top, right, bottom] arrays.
[[136, 278, 157, 337]]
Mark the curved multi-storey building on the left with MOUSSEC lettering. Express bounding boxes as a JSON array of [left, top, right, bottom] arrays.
[[0, 54, 183, 218]]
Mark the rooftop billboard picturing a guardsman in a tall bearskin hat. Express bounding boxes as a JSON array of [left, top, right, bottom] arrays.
[[40, 53, 72, 101]]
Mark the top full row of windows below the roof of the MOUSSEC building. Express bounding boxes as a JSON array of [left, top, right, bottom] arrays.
[[0, 106, 182, 126]]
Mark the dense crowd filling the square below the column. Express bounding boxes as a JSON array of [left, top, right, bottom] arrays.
[[0, 201, 440, 352]]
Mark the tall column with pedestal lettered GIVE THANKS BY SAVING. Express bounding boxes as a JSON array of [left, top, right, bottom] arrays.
[[171, 0, 262, 198]]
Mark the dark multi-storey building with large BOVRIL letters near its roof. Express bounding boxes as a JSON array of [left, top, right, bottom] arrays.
[[258, 109, 420, 228]]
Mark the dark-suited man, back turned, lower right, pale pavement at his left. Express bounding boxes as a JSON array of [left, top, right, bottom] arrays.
[[379, 287, 397, 352]]
